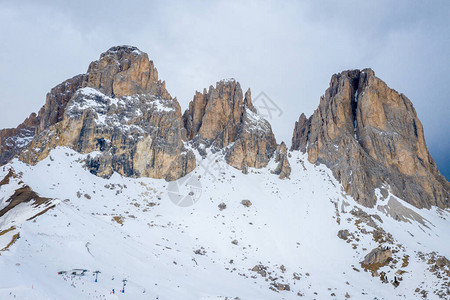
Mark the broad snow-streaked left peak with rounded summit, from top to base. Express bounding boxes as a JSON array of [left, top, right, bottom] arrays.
[[13, 46, 196, 180]]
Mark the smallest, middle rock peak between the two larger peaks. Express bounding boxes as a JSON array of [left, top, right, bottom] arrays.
[[183, 79, 277, 172]]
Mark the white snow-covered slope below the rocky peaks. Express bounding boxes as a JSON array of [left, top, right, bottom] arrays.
[[0, 148, 450, 299]]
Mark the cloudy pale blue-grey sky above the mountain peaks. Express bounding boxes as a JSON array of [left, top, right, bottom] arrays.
[[0, 0, 450, 178]]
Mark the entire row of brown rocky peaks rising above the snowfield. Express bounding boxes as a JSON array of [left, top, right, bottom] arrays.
[[0, 46, 450, 208]]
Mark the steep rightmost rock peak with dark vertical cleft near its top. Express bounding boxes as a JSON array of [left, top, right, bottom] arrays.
[[292, 69, 450, 208]]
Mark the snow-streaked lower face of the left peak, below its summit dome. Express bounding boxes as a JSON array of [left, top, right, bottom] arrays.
[[20, 88, 195, 180]]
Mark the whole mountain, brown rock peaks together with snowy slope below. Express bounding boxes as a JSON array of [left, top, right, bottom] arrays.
[[0, 46, 450, 300]]
